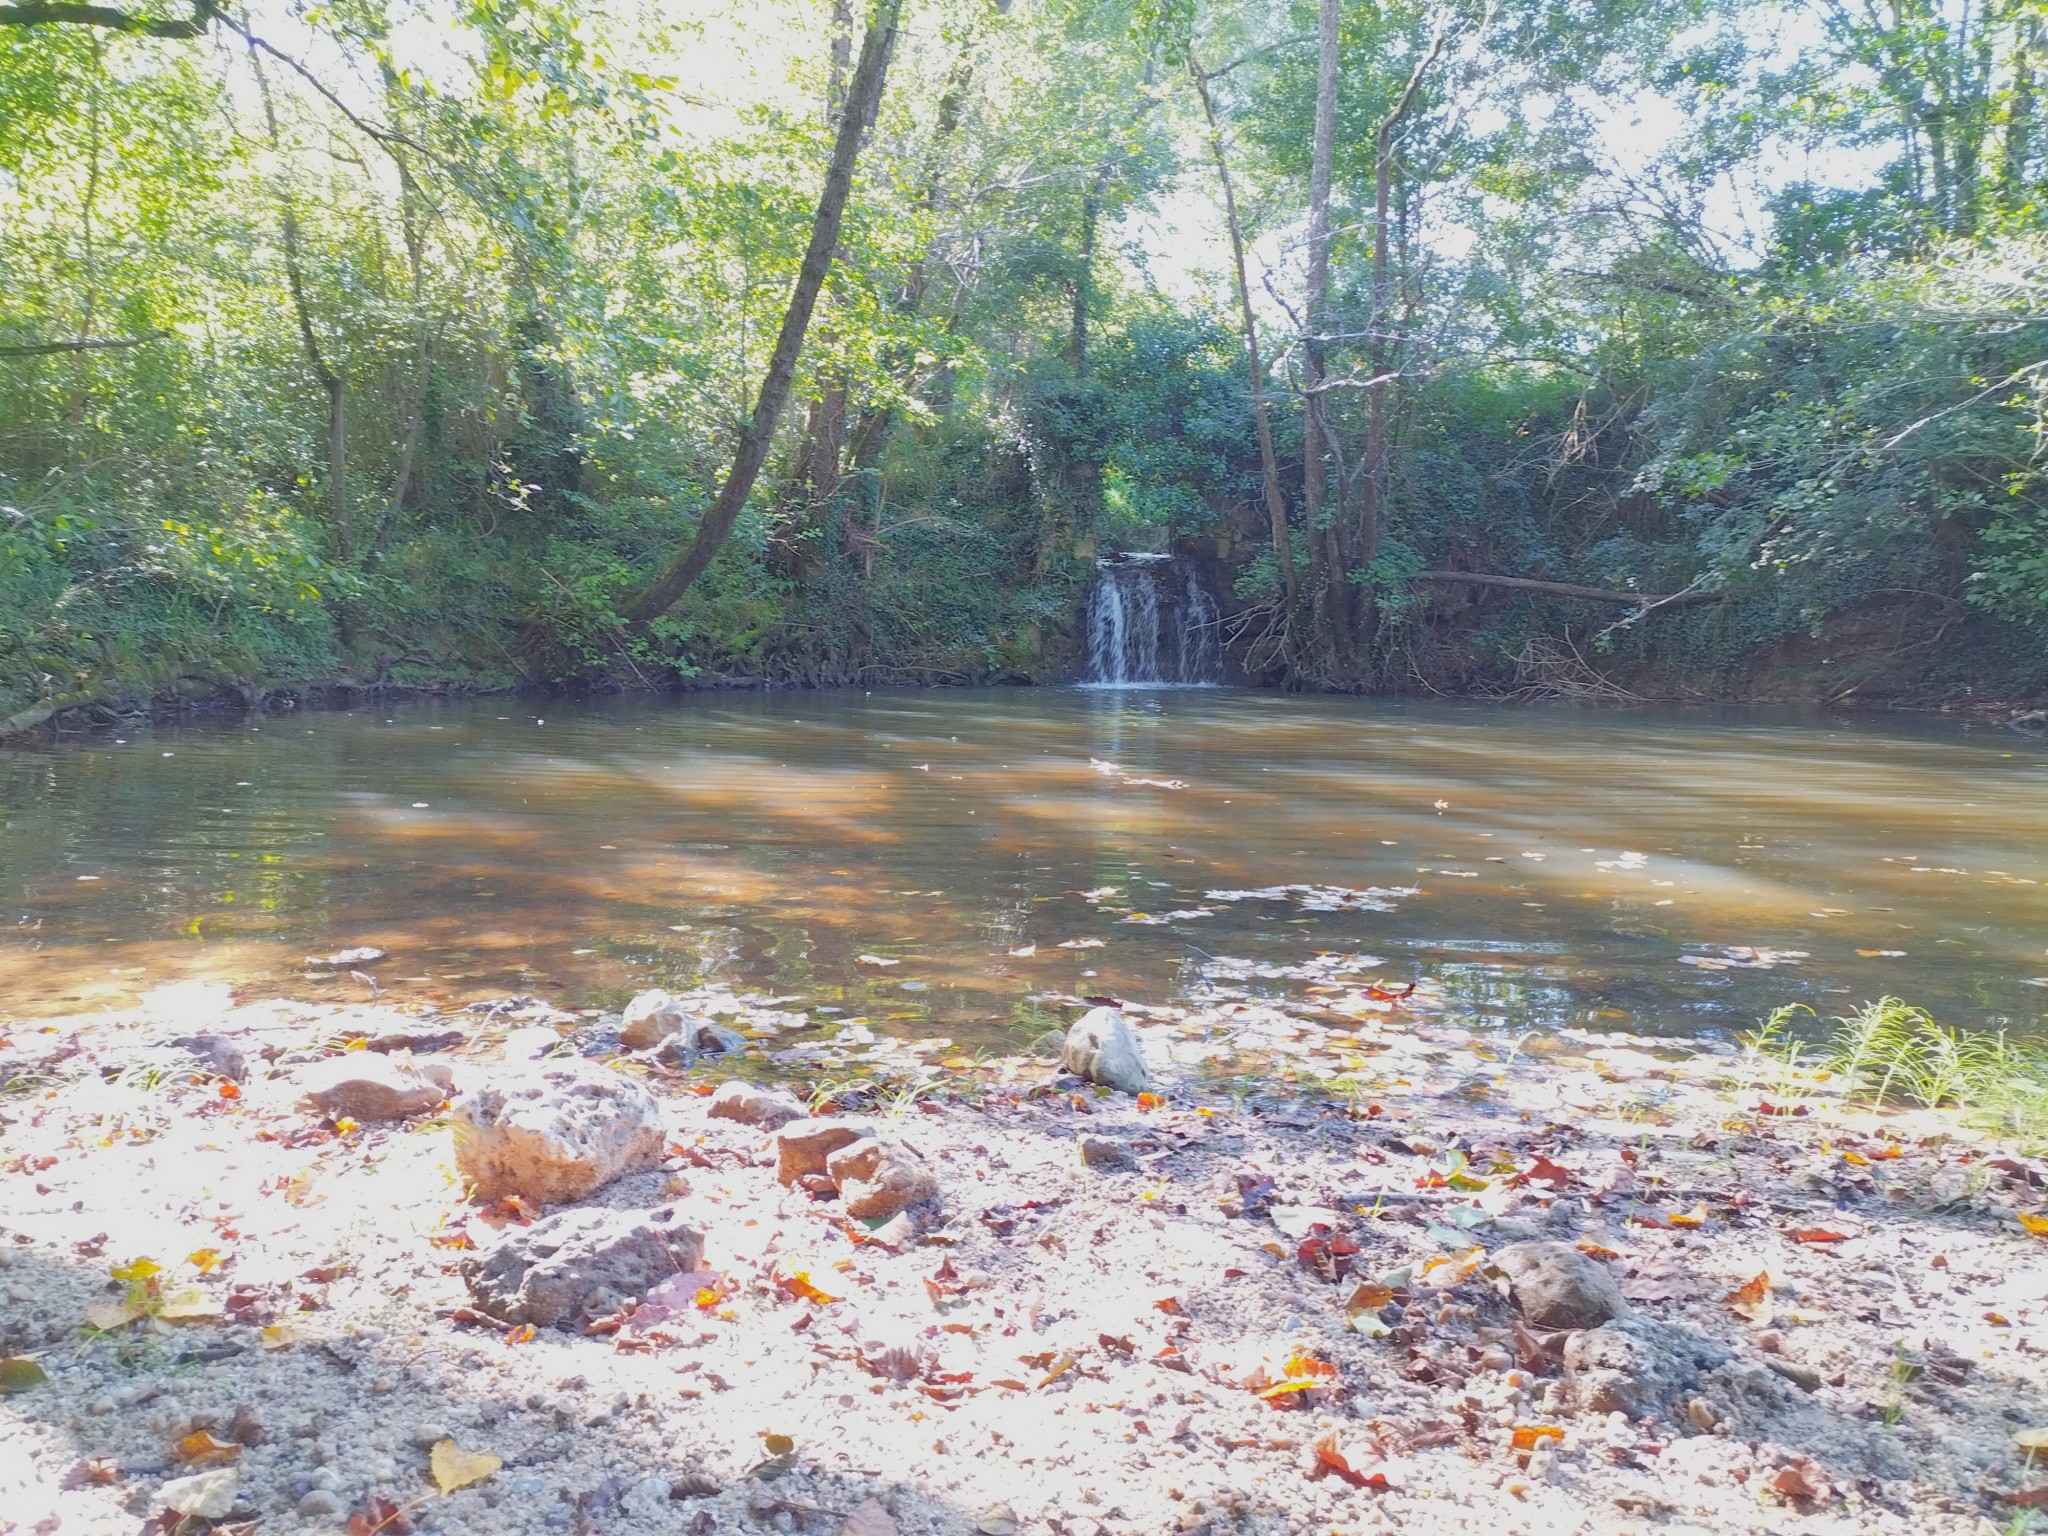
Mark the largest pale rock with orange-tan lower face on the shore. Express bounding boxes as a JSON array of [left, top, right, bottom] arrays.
[[455, 1057, 664, 1204]]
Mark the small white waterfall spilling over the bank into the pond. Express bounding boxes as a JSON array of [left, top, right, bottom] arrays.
[[1081, 555, 1223, 688]]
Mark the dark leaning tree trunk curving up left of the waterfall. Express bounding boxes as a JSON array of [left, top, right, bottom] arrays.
[[627, 0, 901, 623]]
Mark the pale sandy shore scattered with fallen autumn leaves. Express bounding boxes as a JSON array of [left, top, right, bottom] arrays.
[[0, 974, 2048, 1536]]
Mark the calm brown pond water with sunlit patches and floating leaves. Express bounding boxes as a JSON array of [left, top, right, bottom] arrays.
[[0, 690, 2048, 1040]]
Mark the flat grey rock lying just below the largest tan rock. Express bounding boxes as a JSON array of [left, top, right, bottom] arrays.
[[459, 1206, 705, 1327]]
